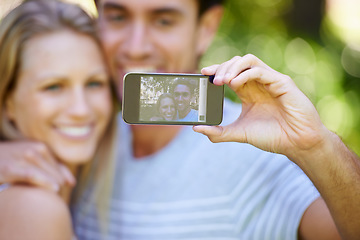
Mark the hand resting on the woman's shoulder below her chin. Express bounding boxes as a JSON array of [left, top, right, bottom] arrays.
[[0, 141, 75, 191]]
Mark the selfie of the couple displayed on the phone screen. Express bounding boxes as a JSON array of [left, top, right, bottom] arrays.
[[139, 76, 208, 122]]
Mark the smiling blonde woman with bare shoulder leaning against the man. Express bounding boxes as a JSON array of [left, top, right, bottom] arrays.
[[0, 0, 116, 240]]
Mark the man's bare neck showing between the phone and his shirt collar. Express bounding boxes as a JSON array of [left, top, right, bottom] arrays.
[[131, 125, 182, 158]]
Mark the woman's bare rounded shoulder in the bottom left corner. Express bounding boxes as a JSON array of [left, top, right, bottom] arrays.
[[0, 185, 72, 240]]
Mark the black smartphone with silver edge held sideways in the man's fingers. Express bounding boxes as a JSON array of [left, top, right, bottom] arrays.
[[122, 73, 224, 125]]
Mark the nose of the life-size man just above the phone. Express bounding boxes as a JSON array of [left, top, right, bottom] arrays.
[[124, 21, 151, 60]]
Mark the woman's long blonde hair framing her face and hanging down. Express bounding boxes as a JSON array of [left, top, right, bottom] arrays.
[[0, 0, 117, 236]]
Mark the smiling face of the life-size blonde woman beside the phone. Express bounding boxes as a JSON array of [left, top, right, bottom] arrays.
[[6, 31, 111, 165]]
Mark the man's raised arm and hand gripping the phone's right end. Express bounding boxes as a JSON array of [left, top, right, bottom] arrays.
[[194, 55, 360, 239]]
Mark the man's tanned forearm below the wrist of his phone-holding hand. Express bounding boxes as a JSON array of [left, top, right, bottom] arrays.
[[294, 132, 360, 239]]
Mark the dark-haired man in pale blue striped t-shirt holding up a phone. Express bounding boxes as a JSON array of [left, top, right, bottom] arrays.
[[0, 0, 360, 240]]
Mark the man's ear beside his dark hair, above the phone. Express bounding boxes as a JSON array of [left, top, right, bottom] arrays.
[[196, 5, 224, 56]]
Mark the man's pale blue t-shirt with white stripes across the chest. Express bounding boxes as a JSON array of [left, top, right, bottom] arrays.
[[72, 98, 319, 240]]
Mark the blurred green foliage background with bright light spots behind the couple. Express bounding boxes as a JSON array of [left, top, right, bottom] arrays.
[[0, 0, 360, 155]]
